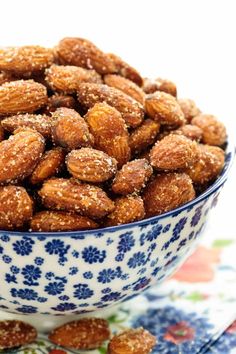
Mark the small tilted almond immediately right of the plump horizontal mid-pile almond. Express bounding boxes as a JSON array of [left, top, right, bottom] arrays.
[[112, 159, 153, 195]]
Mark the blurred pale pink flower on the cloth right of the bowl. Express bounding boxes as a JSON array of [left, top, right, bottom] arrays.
[[172, 246, 221, 283]]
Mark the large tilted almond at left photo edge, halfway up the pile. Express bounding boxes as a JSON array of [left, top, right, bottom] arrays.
[[0, 130, 44, 183]]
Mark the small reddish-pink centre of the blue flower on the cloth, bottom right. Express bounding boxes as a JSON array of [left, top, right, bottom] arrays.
[[164, 321, 195, 345]]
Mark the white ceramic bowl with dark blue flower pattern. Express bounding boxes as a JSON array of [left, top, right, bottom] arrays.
[[0, 138, 234, 330]]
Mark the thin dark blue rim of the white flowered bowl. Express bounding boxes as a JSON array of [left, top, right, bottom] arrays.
[[0, 134, 236, 237]]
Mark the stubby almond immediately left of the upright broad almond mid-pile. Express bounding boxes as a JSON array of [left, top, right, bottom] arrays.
[[52, 107, 94, 150]]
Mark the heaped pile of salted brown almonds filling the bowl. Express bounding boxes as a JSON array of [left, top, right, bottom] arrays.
[[0, 38, 226, 231]]
